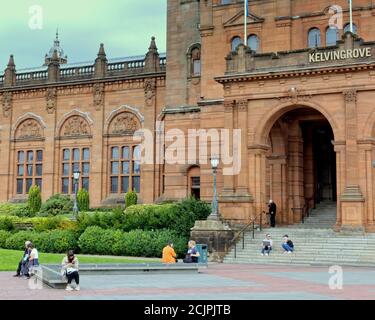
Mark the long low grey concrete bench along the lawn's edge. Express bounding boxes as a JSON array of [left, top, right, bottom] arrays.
[[35, 263, 208, 289]]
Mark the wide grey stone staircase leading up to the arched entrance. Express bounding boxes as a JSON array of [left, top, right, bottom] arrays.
[[224, 203, 375, 267]]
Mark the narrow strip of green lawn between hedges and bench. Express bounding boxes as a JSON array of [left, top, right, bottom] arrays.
[[0, 249, 158, 271]]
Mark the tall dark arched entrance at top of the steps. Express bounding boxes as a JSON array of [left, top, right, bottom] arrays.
[[265, 106, 337, 224]]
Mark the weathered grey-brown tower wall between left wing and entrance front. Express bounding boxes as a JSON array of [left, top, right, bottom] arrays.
[[166, 0, 200, 108]]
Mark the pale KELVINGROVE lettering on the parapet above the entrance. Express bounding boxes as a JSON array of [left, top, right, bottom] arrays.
[[309, 47, 371, 63]]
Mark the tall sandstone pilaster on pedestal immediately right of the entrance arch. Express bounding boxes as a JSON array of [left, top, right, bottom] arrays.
[[340, 90, 365, 229]]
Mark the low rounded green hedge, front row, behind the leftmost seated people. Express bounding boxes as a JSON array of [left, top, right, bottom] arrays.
[[4, 230, 78, 253]]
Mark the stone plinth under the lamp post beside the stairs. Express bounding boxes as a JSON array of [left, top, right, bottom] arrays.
[[191, 220, 234, 262]]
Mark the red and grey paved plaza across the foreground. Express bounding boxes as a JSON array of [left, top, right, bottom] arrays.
[[0, 264, 375, 300]]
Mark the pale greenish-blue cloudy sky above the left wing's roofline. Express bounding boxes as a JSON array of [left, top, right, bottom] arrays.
[[0, 0, 167, 71]]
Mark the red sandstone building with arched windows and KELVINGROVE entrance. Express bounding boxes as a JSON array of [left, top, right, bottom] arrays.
[[0, 0, 375, 231]]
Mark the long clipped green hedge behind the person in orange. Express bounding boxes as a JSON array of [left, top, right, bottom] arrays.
[[78, 226, 187, 257]]
